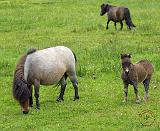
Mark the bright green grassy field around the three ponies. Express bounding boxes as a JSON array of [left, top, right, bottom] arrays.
[[0, 0, 160, 131]]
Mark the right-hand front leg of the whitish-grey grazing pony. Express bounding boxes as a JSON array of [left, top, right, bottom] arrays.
[[34, 80, 40, 110]]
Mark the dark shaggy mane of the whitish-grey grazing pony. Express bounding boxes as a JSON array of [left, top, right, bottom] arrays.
[[13, 49, 36, 104]]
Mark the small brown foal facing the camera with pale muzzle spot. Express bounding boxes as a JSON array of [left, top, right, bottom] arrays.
[[121, 54, 154, 103]]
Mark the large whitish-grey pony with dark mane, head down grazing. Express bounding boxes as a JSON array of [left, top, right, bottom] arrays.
[[13, 46, 79, 114]]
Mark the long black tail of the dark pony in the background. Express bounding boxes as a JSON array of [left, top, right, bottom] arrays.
[[124, 8, 136, 29]]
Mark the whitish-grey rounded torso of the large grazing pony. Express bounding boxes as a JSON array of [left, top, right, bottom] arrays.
[[24, 46, 75, 85]]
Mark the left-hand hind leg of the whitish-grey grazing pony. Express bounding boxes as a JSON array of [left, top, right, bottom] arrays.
[[57, 75, 67, 102]]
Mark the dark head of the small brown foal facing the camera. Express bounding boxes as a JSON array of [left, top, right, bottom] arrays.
[[121, 54, 132, 75]]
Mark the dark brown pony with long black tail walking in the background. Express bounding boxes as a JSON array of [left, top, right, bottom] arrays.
[[100, 4, 136, 30]]
